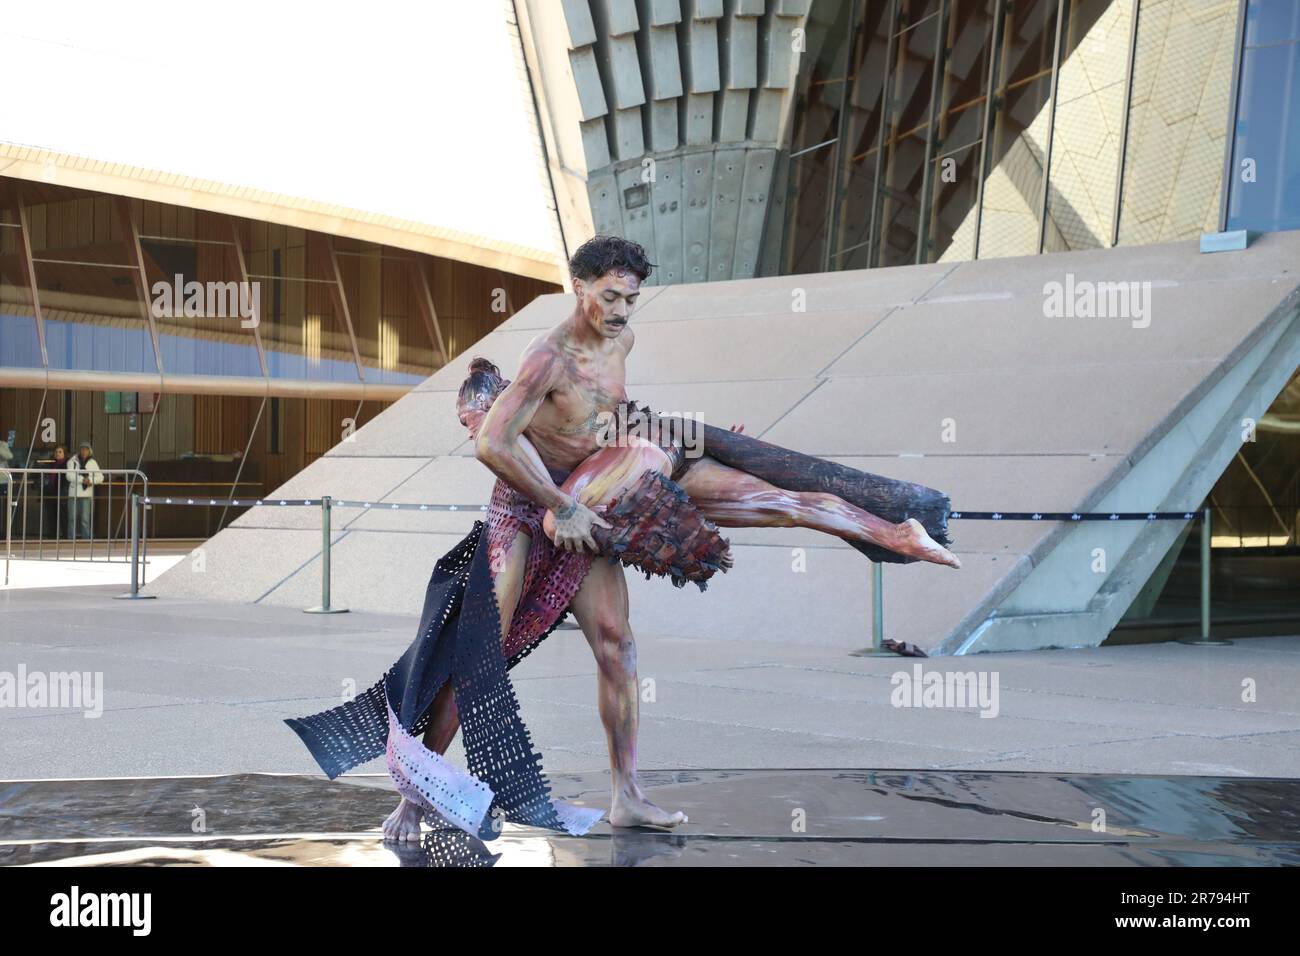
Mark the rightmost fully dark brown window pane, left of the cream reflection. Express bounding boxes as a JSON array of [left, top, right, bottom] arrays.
[[876, 17, 940, 265]]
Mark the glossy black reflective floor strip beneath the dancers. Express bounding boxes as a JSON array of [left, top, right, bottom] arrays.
[[0, 770, 1300, 866]]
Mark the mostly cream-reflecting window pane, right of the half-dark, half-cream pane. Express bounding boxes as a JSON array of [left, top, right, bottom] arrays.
[[1043, 0, 1135, 252]]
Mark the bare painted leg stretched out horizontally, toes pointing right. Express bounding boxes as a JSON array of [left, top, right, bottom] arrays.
[[680, 455, 962, 567]]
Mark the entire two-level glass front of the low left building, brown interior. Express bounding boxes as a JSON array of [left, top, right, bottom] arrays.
[[0, 177, 559, 538]]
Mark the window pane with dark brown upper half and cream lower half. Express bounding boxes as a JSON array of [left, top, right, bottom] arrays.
[[979, 0, 1057, 259]]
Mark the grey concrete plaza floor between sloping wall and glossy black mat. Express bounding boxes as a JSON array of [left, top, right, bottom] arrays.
[[0, 587, 1300, 779]]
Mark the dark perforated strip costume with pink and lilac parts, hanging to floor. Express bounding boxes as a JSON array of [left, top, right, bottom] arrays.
[[286, 480, 602, 840]]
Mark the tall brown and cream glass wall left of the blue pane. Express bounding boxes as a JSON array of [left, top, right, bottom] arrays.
[[764, 0, 1242, 274]]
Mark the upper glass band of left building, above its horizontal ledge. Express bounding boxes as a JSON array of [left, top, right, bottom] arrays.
[[0, 177, 559, 395]]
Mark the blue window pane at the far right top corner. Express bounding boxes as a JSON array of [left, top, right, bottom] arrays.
[[1227, 43, 1300, 232]]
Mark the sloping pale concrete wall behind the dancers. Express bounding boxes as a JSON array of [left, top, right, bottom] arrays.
[[150, 233, 1300, 653]]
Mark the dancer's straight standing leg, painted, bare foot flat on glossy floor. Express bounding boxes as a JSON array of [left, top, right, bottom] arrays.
[[569, 559, 686, 827]]
